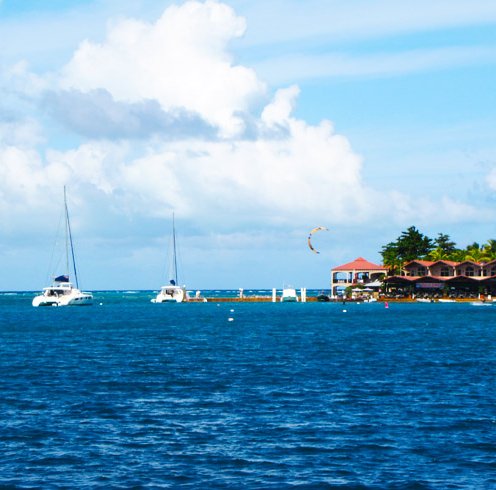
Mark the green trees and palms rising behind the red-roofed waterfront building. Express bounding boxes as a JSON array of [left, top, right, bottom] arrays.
[[380, 226, 496, 274]]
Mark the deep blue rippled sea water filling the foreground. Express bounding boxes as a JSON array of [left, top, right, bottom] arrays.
[[0, 292, 496, 489]]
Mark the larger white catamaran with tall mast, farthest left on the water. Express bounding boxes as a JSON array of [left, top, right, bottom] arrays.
[[33, 186, 93, 306]]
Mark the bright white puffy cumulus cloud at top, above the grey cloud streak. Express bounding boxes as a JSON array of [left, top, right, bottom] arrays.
[[60, 0, 265, 135]]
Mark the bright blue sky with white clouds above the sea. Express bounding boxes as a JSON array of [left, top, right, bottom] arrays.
[[0, 0, 496, 291]]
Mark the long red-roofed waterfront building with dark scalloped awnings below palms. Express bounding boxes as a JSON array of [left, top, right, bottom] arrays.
[[384, 260, 496, 295]]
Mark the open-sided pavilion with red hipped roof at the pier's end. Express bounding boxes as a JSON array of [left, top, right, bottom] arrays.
[[331, 257, 388, 298]]
